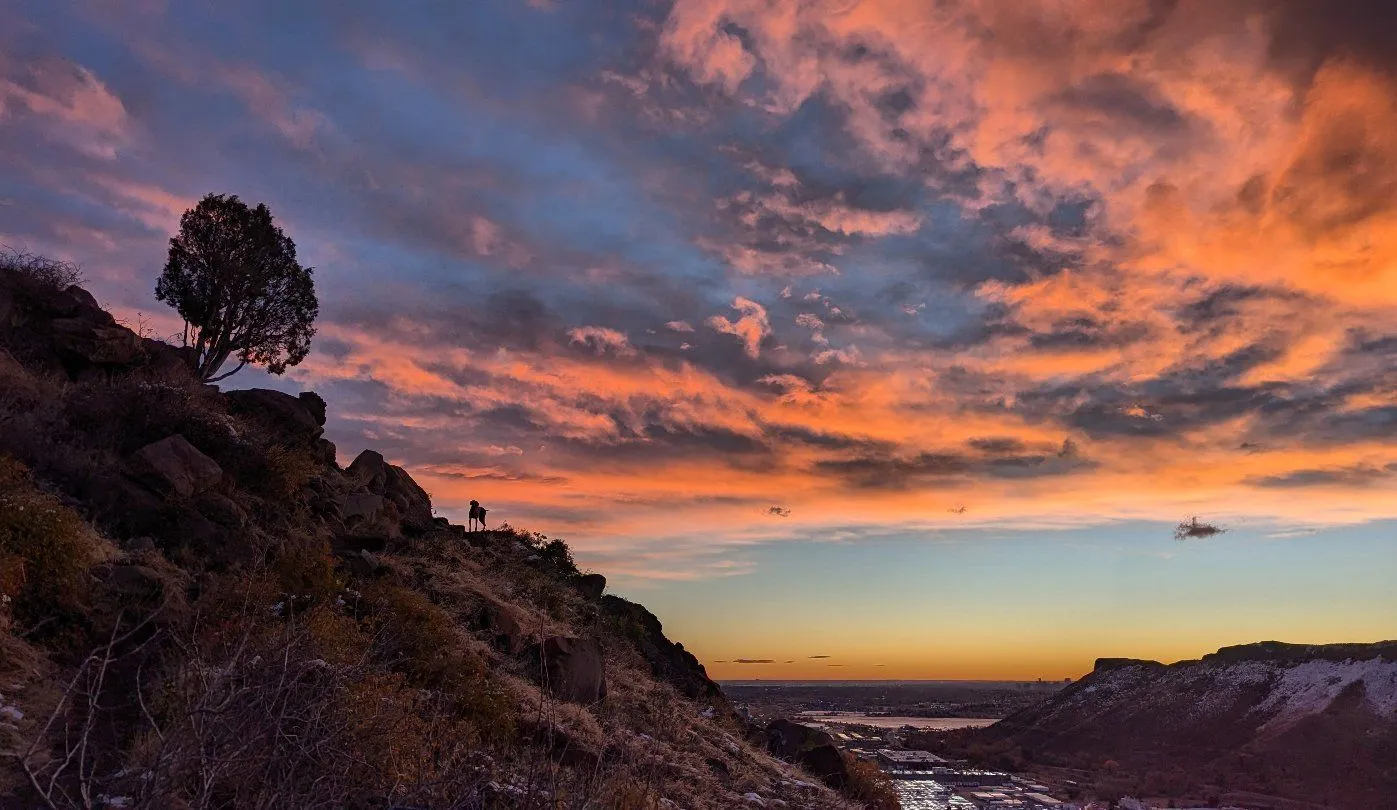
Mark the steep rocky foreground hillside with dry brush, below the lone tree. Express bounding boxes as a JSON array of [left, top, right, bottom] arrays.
[[0, 264, 856, 809]]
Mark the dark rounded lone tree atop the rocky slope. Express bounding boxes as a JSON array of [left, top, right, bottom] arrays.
[[155, 194, 320, 383]]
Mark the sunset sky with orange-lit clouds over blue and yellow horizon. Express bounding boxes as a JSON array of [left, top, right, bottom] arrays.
[[0, 0, 1397, 679]]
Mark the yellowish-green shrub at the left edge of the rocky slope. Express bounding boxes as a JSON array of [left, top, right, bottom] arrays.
[[0, 457, 102, 623]]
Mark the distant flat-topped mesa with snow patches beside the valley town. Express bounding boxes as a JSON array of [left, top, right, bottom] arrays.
[[978, 642, 1397, 809]]
